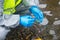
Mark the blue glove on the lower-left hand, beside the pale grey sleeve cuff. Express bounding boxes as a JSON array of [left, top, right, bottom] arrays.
[[20, 15, 35, 27]]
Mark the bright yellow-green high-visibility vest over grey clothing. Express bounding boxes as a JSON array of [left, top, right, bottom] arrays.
[[3, 0, 22, 15]]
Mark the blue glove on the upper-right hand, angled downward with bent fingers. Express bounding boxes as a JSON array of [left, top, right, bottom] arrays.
[[29, 6, 44, 23]]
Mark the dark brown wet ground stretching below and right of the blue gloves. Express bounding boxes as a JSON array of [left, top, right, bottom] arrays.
[[6, 0, 60, 40]]
